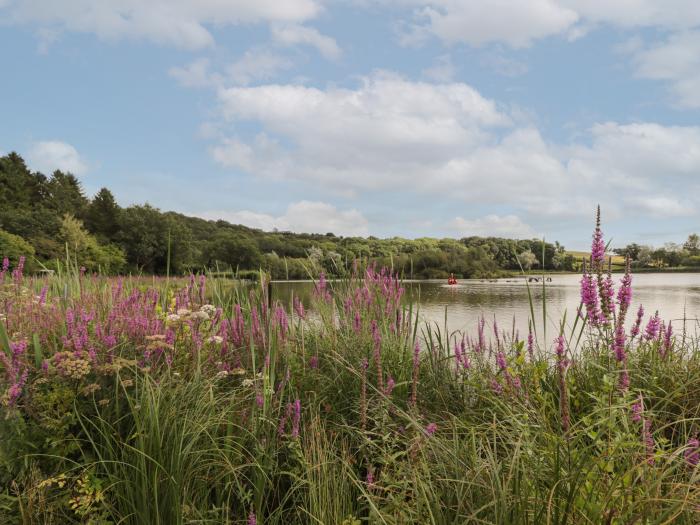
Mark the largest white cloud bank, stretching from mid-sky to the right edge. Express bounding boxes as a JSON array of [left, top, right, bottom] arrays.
[[211, 73, 700, 217]]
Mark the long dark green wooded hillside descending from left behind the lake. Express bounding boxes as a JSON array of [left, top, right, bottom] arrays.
[[0, 153, 576, 279]]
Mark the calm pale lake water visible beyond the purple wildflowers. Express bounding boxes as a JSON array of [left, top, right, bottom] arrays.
[[272, 273, 700, 333]]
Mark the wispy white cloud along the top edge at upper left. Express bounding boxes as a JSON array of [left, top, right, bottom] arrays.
[[0, 0, 321, 49]]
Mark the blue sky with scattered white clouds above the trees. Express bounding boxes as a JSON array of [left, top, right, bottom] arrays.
[[0, 0, 700, 249]]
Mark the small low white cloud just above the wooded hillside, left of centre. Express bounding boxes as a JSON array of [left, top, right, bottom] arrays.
[[198, 201, 369, 237]]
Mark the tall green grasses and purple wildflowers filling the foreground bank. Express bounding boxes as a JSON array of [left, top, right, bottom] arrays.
[[0, 210, 700, 525]]
